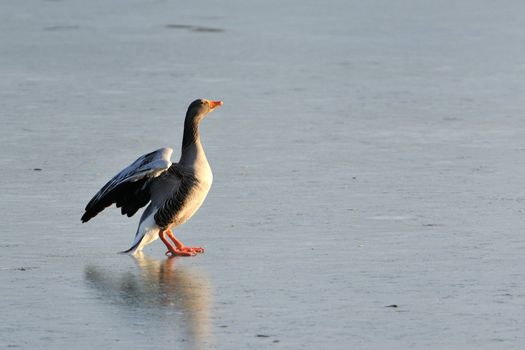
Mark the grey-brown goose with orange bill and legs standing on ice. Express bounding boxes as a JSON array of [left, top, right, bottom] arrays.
[[81, 99, 223, 257]]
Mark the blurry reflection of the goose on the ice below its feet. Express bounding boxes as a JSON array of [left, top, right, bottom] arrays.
[[85, 253, 212, 349]]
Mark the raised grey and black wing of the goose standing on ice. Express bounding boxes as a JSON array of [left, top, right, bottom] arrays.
[[81, 148, 173, 222]]
